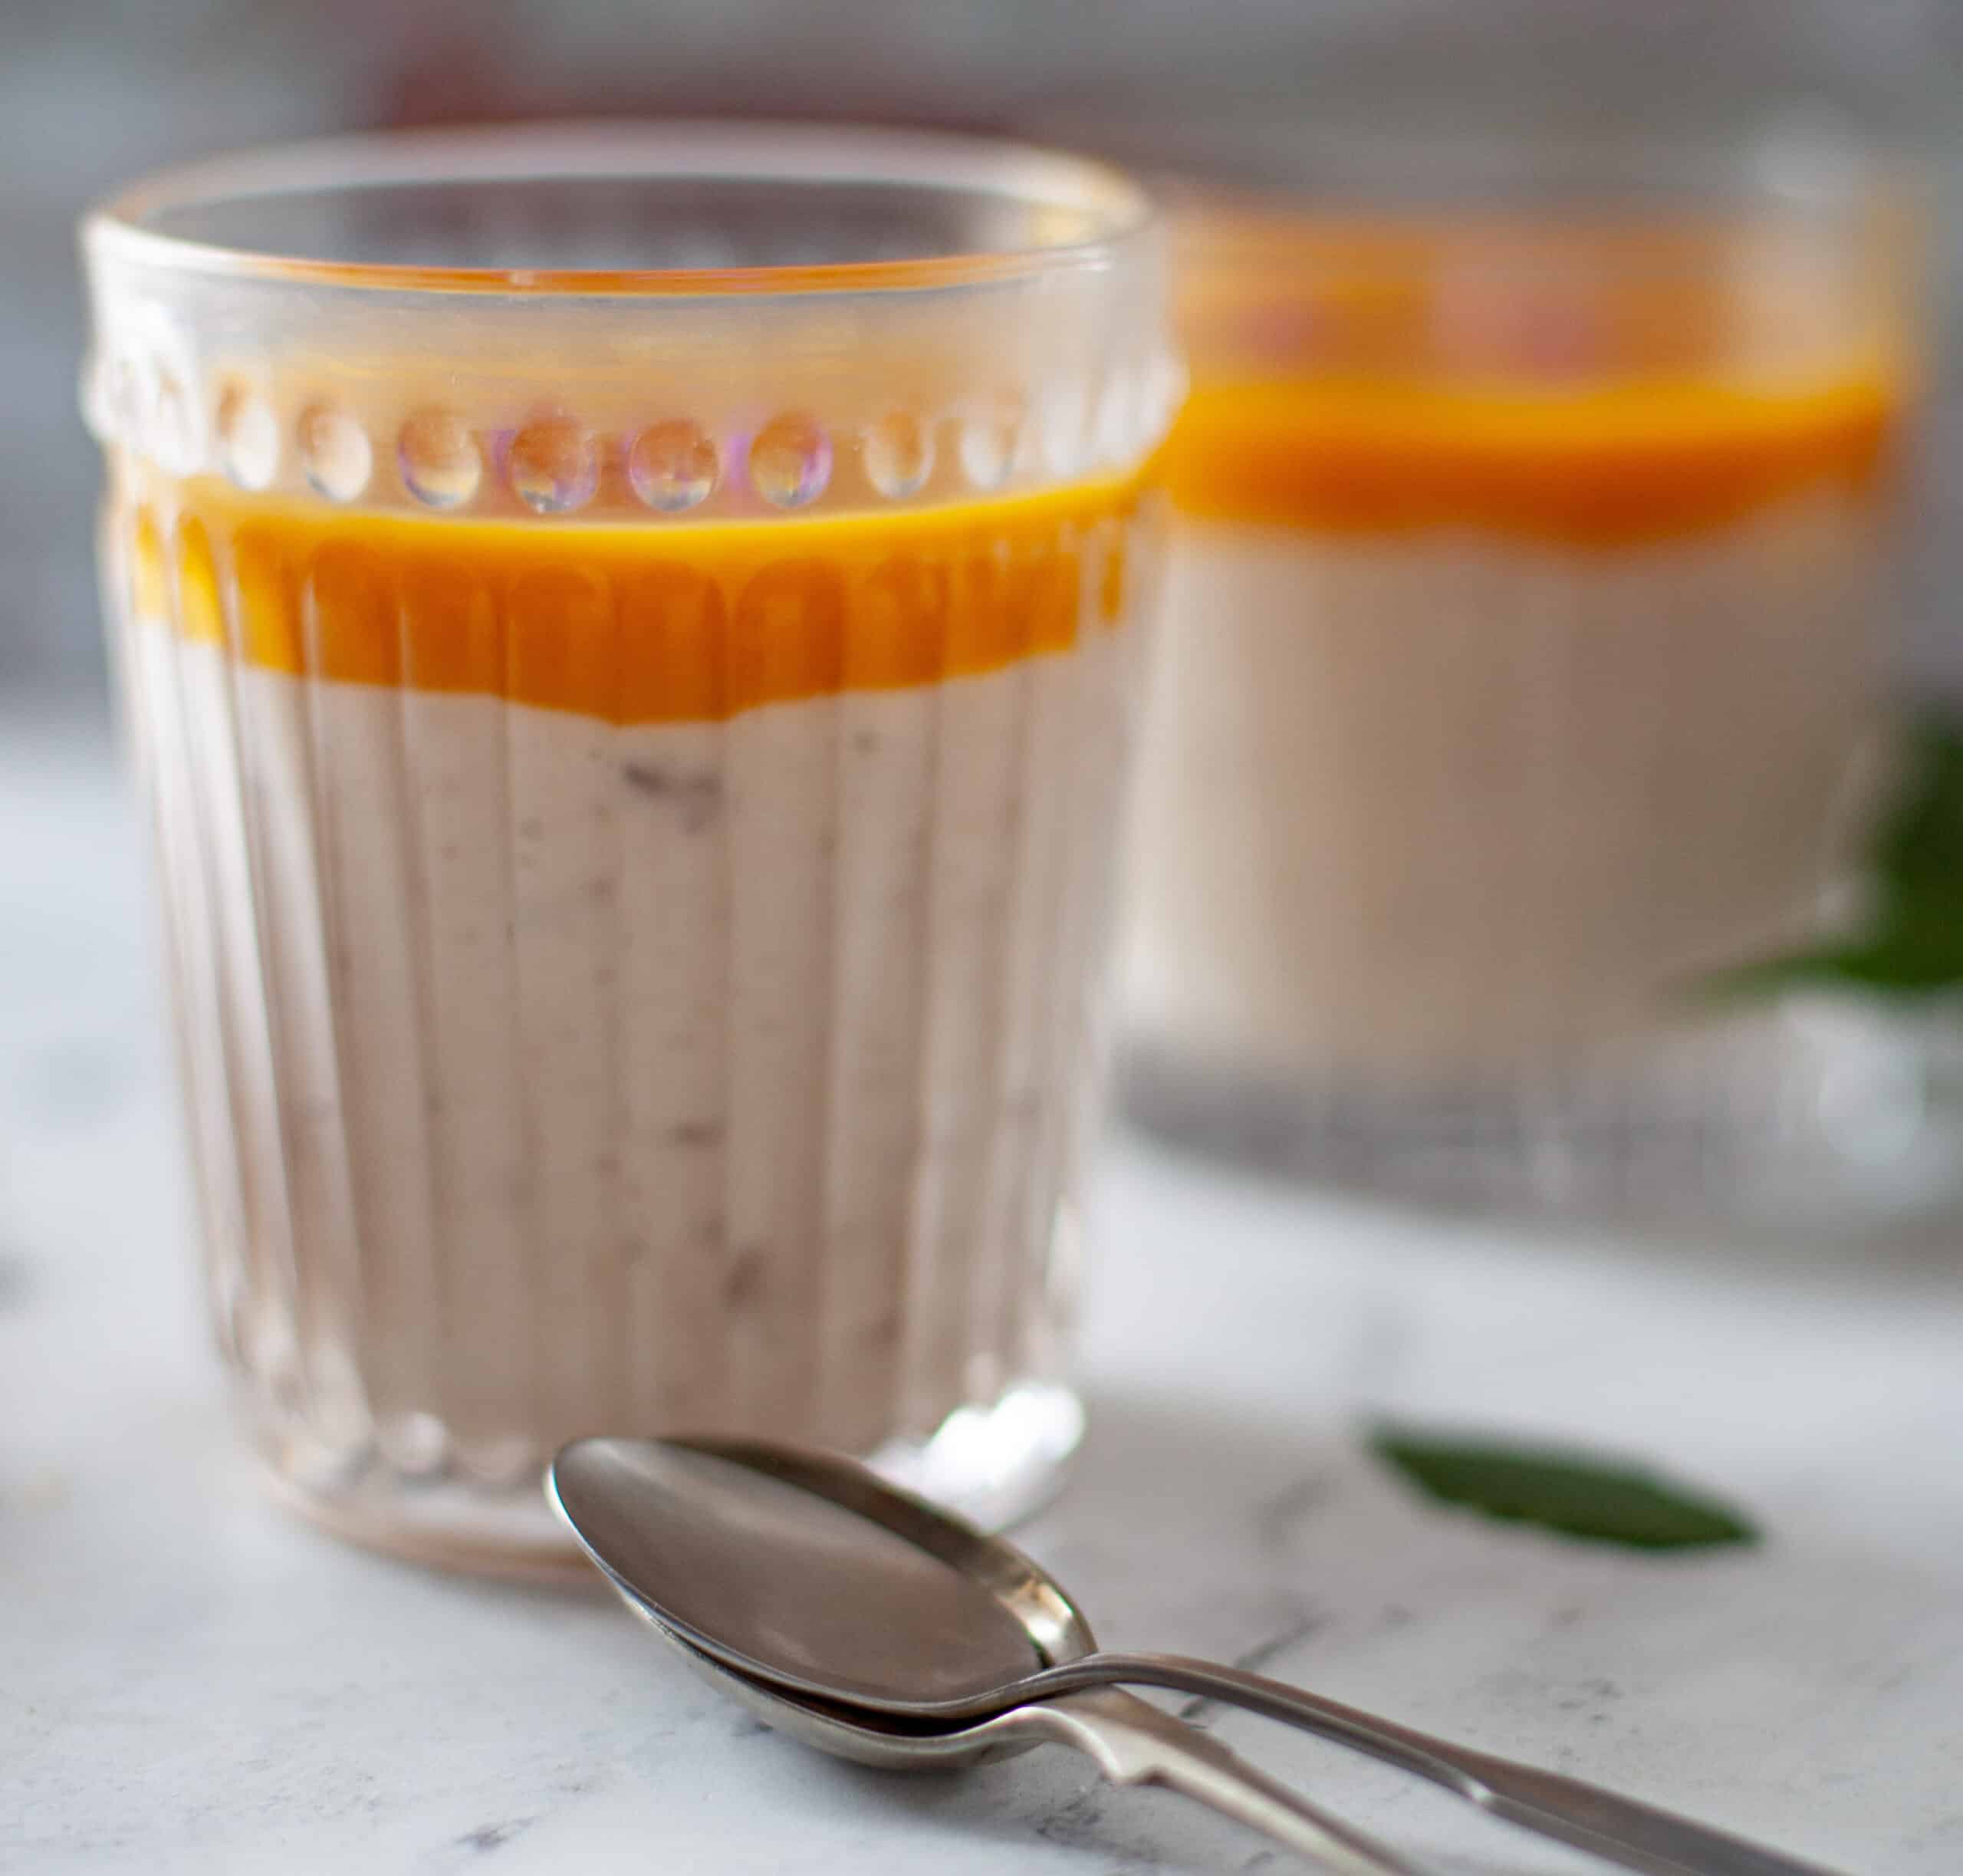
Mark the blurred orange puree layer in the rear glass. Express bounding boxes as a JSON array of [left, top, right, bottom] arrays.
[[1166, 367, 1900, 548]]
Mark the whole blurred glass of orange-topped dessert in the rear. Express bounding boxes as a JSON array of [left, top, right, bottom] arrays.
[[1126, 133, 1912, 1208]]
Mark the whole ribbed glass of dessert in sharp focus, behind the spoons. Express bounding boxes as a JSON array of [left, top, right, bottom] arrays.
[[84, 126, 1175, 1569]]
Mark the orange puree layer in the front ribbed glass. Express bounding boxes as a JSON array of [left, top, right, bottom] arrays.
[[116, 477, 1146, 723]]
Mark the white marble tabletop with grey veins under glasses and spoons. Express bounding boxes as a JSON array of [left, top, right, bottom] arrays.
[[0, 711, 1963, 1876]]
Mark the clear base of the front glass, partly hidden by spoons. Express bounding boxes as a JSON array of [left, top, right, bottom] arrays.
[[251, 1381, 1083, 1581]]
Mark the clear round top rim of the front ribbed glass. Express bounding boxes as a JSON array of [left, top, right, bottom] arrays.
[[92, 118, 1158, 298]]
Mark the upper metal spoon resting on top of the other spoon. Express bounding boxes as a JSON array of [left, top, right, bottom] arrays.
[[547, 1438, 1853, 1876]]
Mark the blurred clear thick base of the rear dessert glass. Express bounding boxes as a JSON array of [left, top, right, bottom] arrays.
[[1117, 1004, 1963, 1229]]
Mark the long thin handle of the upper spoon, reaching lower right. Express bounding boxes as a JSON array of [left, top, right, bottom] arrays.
[[1083, 1654, 1833, 1876]]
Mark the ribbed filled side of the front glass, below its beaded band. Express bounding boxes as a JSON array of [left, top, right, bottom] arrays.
[[106, 479, 1150, 1572]]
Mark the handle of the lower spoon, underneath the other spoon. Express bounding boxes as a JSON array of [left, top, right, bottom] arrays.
[[1013, 1687, 1421, 1876]]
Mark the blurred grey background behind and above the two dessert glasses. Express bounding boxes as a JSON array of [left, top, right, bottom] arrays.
[[12, 0, 1963, 711]]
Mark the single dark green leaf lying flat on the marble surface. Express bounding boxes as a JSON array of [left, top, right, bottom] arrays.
[[1370, 1424, 1759, 1550]]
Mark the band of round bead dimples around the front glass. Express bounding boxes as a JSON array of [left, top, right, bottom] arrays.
[[83, 351, 1184, 518]]
